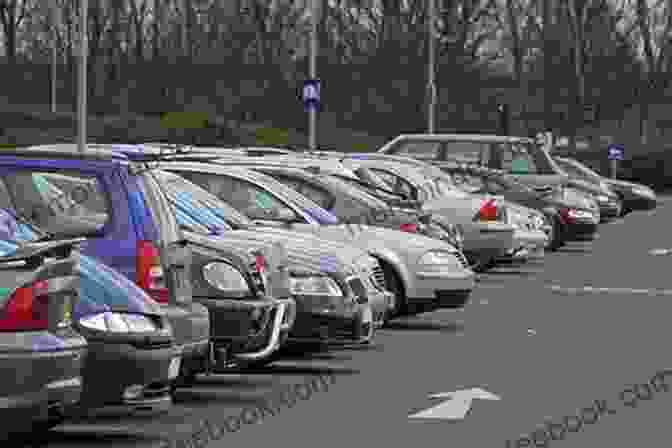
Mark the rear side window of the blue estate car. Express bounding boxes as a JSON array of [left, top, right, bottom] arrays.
[[2, 170, 111, 236]]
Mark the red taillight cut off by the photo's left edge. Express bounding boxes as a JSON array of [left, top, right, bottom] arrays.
[[0, 280, 49, 331]]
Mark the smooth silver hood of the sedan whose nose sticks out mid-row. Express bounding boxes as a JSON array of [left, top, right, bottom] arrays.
[[288, 224, 455, 255]]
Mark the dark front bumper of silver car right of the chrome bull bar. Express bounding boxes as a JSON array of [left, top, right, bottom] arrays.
[[288, 304, 374, 345]]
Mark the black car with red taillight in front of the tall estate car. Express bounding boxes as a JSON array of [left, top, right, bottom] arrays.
[[444, 166, 598, 245]]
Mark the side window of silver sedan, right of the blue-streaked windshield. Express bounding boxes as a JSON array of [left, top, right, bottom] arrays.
[[180, 171, 298, 219]]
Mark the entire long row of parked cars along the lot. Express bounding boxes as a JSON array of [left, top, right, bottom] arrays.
[[0, 134, 656, 435]]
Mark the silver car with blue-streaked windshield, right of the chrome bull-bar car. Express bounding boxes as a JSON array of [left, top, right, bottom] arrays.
[[146, 168, 380, 345]]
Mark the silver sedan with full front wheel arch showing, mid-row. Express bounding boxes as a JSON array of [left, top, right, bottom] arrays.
[[157, 162, 475, 315]]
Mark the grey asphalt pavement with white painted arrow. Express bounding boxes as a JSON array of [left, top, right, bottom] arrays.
[[26, 198, 672, 448]]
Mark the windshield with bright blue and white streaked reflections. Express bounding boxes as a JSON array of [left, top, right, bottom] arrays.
[[156, 170, 252, 234]]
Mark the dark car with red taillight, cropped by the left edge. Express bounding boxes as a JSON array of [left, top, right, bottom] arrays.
[[0, 226, 87, 440]]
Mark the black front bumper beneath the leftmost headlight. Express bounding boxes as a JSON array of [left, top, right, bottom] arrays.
[[80, 340, 181, 409]]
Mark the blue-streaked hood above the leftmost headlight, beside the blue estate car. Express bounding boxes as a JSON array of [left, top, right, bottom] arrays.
[[73, 255, 163, 319]]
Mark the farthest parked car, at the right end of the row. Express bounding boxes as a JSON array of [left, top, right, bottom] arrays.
[[553, 157, 657, 216]]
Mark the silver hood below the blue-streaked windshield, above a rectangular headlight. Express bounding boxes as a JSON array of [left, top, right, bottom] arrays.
[[185, 227, 368, 275]]
